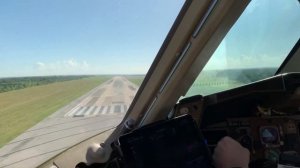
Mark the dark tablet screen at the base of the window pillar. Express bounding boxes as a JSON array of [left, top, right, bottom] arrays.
[[119, 116, 211, 168]]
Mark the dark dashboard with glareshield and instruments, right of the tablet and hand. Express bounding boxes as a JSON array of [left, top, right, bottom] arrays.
[[175, 73, 300, 167]]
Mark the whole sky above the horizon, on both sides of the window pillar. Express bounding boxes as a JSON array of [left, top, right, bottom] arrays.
[[0, 0, 300, 77]]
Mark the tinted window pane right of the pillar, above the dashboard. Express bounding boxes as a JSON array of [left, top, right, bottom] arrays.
[[186, 0, 300, 97]]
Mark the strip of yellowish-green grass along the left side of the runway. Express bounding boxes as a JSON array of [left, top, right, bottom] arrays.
[[0, 76, 109, 147]]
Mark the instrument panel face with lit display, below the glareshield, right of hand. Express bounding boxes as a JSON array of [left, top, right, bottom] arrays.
[[202, 116, 300, 163]]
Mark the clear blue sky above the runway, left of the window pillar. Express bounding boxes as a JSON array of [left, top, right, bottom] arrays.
[[0, 0, 183, 77]]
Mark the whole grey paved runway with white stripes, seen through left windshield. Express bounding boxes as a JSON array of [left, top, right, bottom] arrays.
[[0, 76, 138, 168]]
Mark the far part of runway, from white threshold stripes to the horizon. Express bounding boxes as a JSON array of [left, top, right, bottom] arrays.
[[64, 77, 138, 117]]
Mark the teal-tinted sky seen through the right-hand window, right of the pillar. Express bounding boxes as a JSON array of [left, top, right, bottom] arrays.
[[205, 0, 300, 70]]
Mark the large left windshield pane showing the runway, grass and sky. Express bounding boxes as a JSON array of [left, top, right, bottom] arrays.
[[0, 0, 184, 167]]
